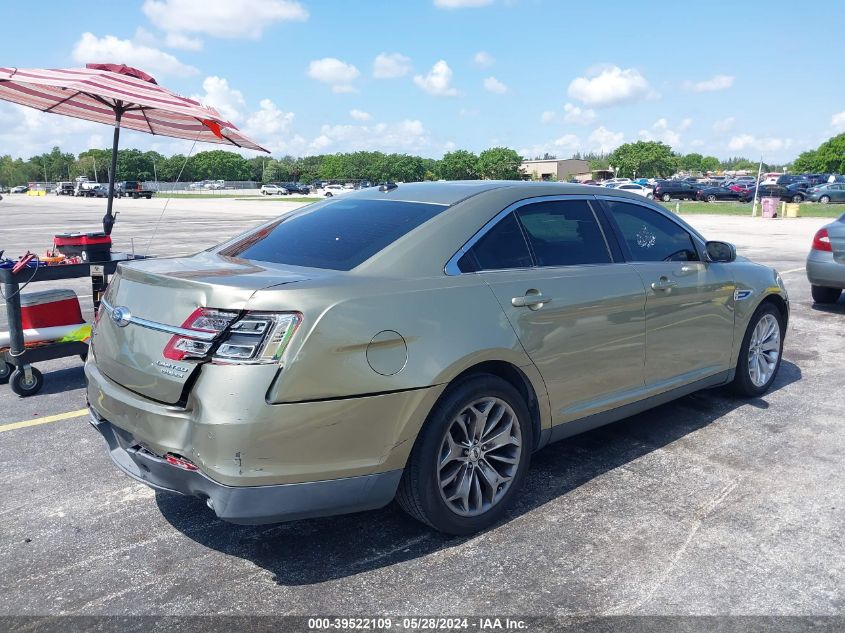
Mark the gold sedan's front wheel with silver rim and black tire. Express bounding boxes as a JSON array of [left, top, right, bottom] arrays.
[[732, 301, 784, 398]]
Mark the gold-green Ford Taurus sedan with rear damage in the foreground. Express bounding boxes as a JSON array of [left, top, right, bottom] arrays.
[[85, 181, 789, 534]]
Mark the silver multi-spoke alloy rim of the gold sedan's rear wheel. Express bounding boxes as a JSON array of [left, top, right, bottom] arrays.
[[437, 398, 523, 517]]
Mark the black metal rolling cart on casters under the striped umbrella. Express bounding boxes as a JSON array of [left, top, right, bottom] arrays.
[[0, 253, 142, 397]]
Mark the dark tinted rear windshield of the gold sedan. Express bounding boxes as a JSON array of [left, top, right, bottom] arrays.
[[220, 199, 448, 270]]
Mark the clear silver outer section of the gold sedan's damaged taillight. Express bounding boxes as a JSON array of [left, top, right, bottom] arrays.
[[211, 312, 302, 364]]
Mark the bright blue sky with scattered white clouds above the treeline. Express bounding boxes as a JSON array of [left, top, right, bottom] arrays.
[[0, 0, 845, 162]]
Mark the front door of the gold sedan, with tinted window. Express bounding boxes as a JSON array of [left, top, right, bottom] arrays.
[[603, 197, 735, 393]]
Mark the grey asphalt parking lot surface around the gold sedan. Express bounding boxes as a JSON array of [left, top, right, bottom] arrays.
[[0, 196, 845, 616]]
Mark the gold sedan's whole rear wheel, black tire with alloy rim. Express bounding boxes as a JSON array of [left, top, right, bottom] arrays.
[[396, 374, 532, 535]]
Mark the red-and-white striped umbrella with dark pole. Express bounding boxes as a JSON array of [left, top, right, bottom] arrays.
[[0, 64, 269, 233]]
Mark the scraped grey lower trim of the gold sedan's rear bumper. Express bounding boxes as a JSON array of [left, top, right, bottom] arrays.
[[90, 410, 402, 525]]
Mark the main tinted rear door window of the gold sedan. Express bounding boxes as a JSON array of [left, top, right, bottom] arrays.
[[517, 200, 611, 266]]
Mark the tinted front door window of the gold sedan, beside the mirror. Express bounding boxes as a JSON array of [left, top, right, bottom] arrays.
[[605, 200, 699, 262]]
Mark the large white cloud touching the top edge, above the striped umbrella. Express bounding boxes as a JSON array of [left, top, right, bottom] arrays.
[[142, 0, 308, 39]]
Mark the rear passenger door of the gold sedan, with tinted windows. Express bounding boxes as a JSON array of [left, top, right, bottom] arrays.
[[460, 196, 645, 424]]
